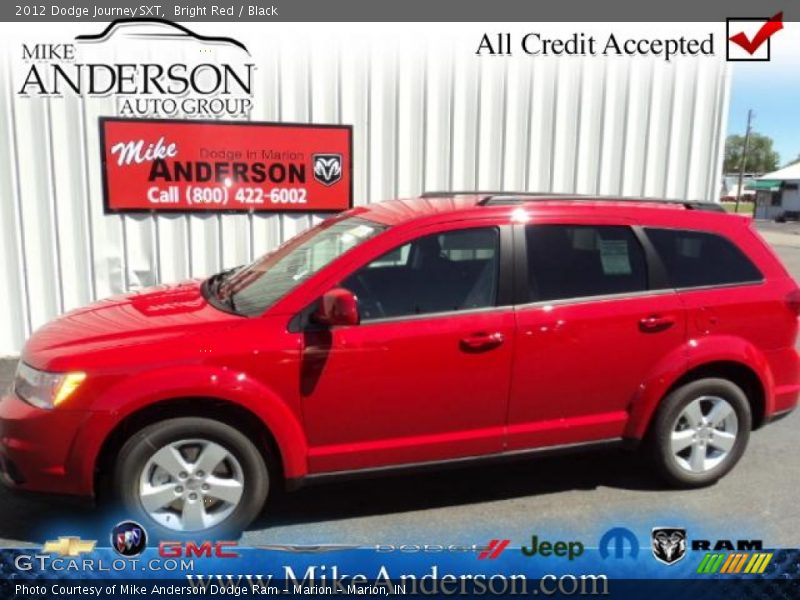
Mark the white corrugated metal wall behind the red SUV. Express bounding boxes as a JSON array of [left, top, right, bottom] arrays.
[[0, 30, 728, 355]]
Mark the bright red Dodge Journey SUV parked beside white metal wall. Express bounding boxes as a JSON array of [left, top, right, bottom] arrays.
[[0, 193, 800, 533]]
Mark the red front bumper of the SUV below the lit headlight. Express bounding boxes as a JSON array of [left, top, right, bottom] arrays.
[[0, 392, 86, 495]]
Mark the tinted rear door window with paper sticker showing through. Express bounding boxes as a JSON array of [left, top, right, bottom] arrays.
[[525, 225, 647, 301]]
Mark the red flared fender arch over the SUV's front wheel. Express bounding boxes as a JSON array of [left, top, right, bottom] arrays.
[[68, 365, 308, 493]]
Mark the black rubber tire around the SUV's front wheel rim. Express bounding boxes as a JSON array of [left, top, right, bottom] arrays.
[[113, 417, 270, 539]]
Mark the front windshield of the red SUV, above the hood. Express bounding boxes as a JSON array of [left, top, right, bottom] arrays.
[[206, 217, 386, 316]]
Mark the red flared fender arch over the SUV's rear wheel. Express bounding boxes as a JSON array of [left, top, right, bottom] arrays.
[[624, 335, 775, 439]]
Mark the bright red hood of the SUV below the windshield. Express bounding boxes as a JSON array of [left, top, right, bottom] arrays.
[[23, 281, 242, 370]]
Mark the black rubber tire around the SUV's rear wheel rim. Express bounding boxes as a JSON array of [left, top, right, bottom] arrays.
[[648, 378, 752, 488]]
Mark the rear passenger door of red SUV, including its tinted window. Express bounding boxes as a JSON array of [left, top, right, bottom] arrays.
[[508, 219, 686, 450]]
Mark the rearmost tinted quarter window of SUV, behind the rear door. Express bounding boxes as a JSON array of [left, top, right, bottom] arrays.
[[645, 228, 764, 288]]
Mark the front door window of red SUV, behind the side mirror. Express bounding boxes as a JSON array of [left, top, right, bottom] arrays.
[[342, 227, 500, 321]]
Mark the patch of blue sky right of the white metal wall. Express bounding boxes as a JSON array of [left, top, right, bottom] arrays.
[[728, 23, 800, 166]]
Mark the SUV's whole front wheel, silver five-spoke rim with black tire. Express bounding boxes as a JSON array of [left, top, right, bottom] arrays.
[[114, 417, 269, 535]]
